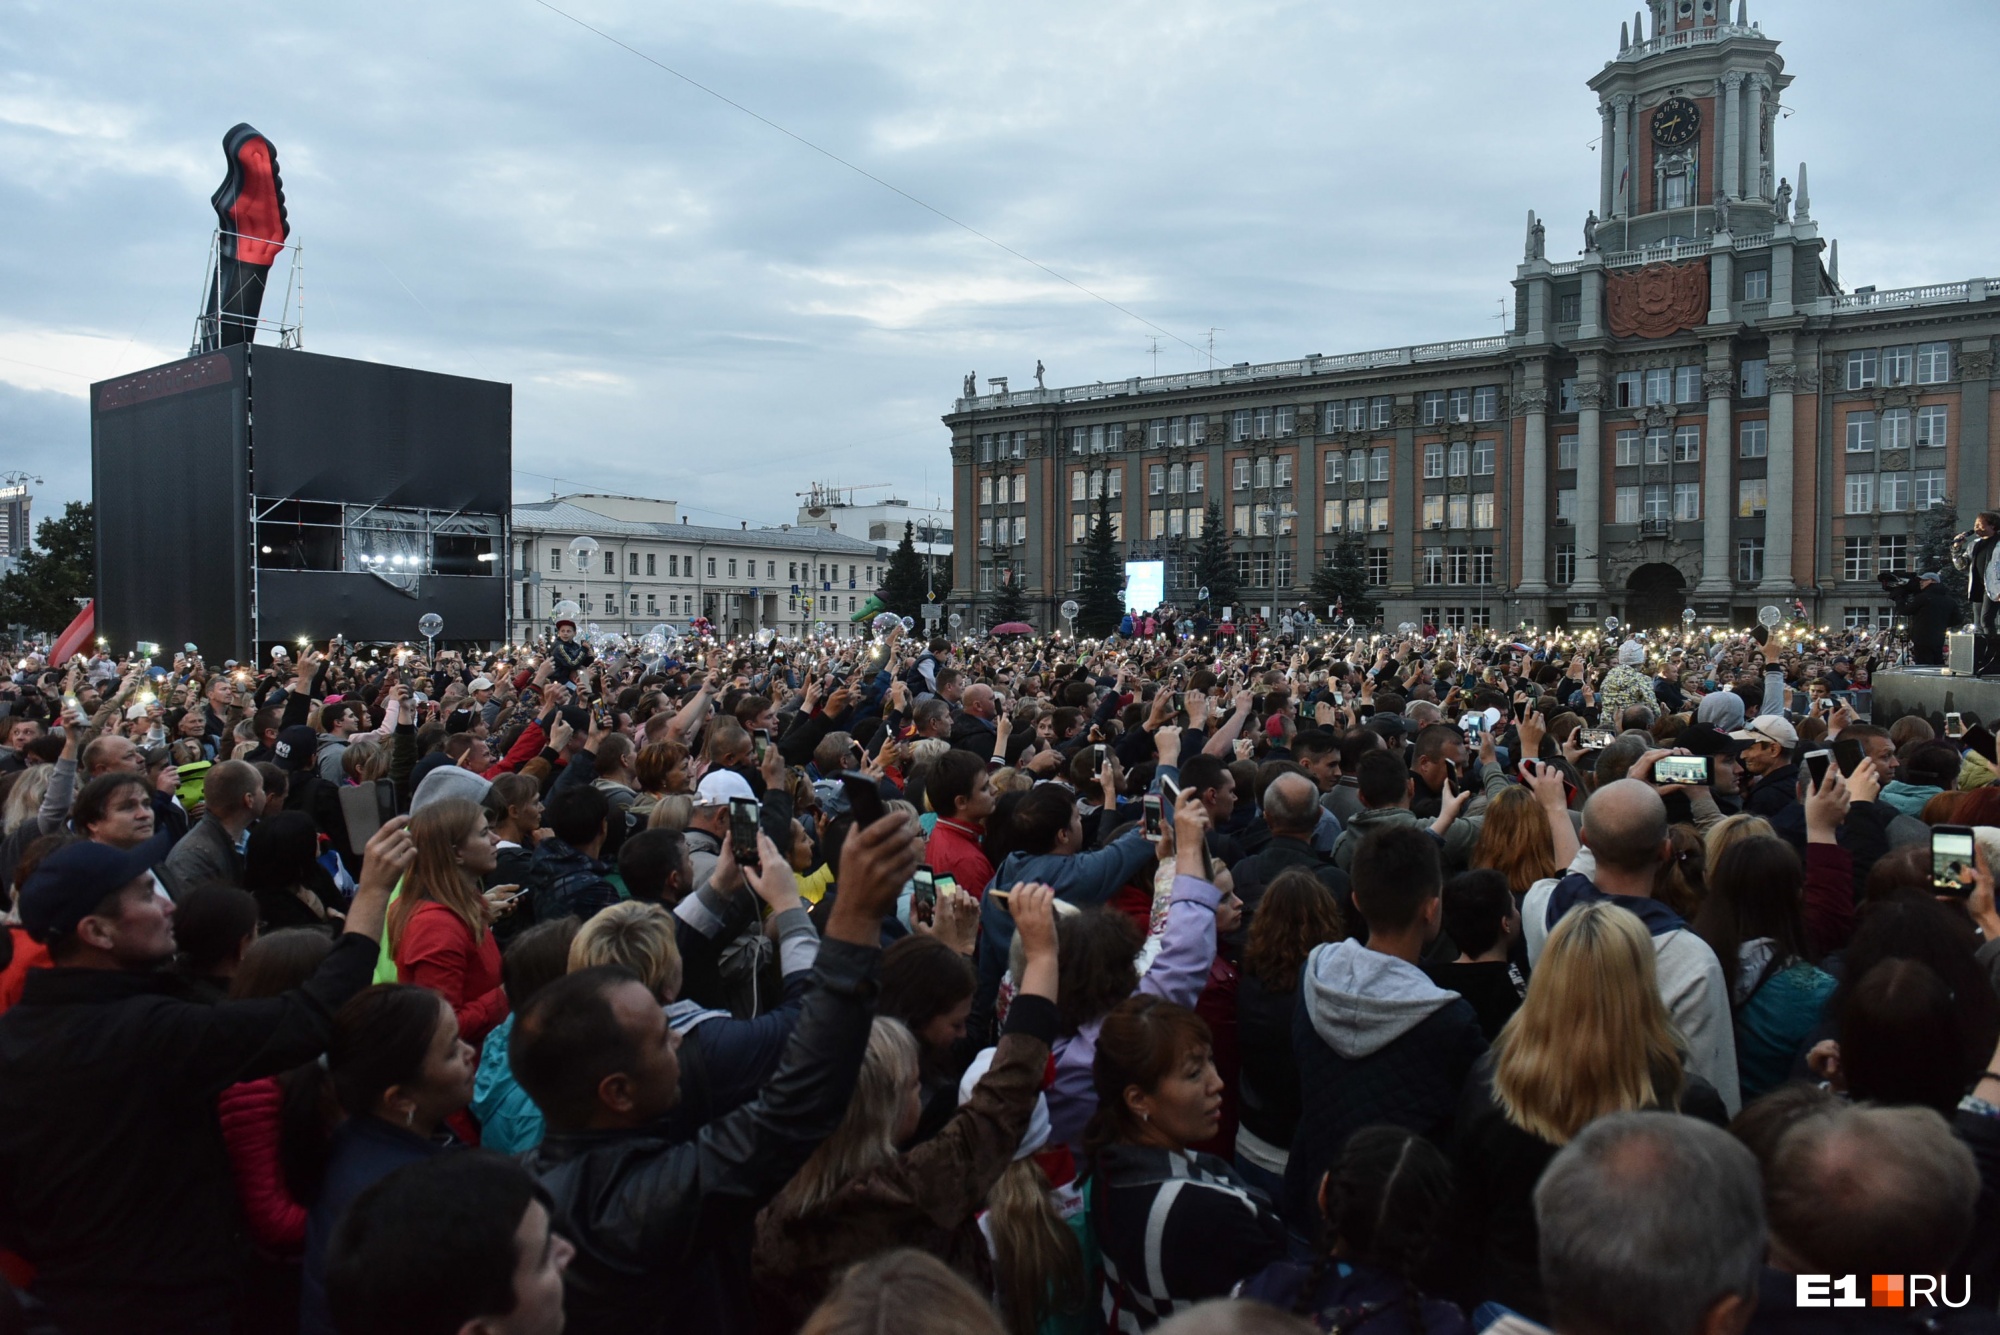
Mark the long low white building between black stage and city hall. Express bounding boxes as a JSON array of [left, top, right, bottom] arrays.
[[508, 492, 884, 640]]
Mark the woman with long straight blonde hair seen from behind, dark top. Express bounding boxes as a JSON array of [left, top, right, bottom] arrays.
[[1452, 901, 1728, 1323]]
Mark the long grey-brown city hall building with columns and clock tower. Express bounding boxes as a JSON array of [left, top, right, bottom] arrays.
[[944, 0, 2000, 628]]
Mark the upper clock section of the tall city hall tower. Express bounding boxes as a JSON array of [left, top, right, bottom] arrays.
[[1590, 0, 1792, 252]]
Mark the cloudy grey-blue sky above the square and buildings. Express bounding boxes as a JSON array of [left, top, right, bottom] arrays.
[[0, 0, 2000, 524]]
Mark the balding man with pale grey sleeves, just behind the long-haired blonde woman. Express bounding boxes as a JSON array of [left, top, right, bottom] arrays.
[[1520, 765, 1742, 1117]]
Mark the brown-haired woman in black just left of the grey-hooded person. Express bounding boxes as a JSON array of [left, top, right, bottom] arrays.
[[1236, 867, 1348, 1201]]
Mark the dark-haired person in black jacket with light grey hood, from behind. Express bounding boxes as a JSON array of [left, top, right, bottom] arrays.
[[1280, 825, 1486, 1237]]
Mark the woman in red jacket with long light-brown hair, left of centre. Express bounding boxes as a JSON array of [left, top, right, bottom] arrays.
[[382, 797, 520, 1047]]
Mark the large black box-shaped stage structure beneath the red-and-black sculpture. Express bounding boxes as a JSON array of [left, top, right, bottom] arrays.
[[90, 344, 514, 662]]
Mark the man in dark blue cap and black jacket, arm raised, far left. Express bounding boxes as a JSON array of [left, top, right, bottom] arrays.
[[0, 817, 416, 1335]]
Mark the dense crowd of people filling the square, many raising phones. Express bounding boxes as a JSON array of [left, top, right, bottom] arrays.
[[0, 618, 2000, 1335]]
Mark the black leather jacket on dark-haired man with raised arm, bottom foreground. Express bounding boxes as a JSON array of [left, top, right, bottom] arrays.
[[522, 941, 882, 1335]]
